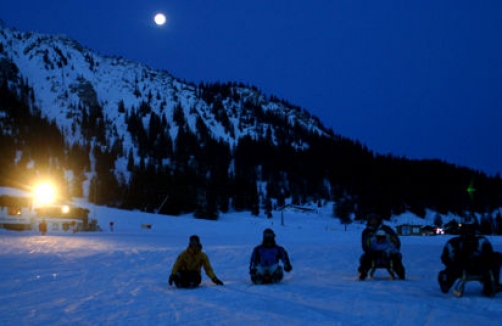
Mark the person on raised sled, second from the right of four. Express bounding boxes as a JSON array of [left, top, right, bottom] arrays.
[[358, 214, 405, 280]]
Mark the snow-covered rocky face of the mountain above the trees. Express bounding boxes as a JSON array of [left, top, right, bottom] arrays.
[[0, 26, 327, 152]]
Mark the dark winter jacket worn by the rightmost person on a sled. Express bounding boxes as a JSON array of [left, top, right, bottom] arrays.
[[441, 235, 493, 273]]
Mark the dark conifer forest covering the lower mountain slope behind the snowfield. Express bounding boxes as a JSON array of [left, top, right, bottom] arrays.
[[0, 80, 502, 224]]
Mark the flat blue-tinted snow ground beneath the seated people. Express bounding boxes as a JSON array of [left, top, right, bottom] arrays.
[[0, 207, 502, 326]]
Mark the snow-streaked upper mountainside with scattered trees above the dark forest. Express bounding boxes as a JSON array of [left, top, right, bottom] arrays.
[[0, 26, 352, 211]]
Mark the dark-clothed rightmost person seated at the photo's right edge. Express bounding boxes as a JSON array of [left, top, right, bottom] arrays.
[[438, 220, 502, 297]]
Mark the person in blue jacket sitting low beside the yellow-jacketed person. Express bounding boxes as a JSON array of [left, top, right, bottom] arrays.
[[249, 229, 293, 284]]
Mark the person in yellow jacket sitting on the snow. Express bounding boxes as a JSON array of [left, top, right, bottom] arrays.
[[169, 235, 223, 288]]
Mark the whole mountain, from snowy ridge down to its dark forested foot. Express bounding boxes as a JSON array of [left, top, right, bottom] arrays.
[[0, 25, 502, 216]]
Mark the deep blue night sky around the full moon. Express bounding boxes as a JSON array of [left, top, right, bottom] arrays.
[[0, 0, 502, 175]]
